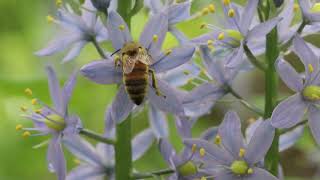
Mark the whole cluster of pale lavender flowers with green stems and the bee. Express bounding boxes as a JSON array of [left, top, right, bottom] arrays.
[[16, 0, 320, 180]]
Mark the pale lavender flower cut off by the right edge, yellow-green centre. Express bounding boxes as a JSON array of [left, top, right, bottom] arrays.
[[271, 36, 320, 143]]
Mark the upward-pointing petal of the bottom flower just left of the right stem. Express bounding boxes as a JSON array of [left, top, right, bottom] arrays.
[[218, 111, 244, 159]]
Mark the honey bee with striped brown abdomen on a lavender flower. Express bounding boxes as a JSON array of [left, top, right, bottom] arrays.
[[115, 42, 165, 105]]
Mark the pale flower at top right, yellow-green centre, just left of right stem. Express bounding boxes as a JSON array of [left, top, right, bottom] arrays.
[[191, 0, 281, 67]]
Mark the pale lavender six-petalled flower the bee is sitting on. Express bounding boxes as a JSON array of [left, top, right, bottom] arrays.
[[81, 12, 195, 122]]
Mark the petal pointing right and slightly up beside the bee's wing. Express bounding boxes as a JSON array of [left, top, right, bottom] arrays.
[[151, 45, 195, 73]]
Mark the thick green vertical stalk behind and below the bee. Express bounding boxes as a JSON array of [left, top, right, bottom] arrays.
[[114, 0, 132, 180]]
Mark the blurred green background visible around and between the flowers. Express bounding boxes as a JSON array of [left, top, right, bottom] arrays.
[[0, 0, 320, 180]]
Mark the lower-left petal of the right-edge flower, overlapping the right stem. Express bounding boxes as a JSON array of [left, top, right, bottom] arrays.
[[271, 93, 307, 128]]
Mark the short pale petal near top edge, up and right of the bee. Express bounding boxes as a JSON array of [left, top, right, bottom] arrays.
[[167, 1, 191, 24]]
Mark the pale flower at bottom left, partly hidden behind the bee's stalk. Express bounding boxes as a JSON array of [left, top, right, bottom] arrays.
[[63, 129, 154, 180]]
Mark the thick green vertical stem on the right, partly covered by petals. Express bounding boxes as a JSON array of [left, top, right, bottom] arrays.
[[264, 28, 280, 176]]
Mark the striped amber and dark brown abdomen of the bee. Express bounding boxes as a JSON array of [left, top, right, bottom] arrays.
[[123, 61, 149, 105]]
